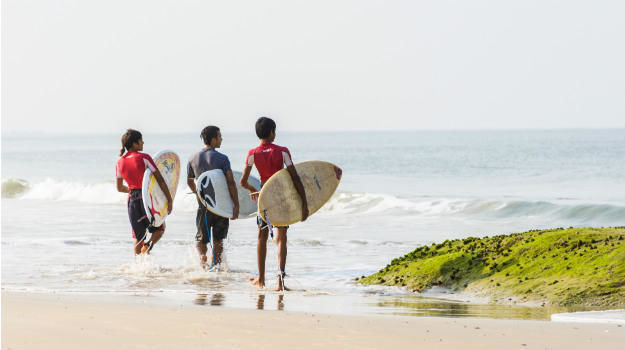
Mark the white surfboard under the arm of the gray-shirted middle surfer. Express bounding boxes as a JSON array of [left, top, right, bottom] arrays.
[[195, 169, 260, 218]]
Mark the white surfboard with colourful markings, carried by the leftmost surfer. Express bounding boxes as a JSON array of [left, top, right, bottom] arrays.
[[141, 151, 180, 227]]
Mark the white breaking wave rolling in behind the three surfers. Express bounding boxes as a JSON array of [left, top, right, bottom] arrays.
[[2, 179, 625, 225]]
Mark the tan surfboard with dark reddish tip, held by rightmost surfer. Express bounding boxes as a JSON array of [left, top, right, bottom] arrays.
[[258, 160, 342, 226]]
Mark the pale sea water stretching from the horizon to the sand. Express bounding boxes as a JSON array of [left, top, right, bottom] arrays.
[[2, 129, 625, 318]]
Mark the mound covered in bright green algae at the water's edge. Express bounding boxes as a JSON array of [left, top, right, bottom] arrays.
[[358, 227, 625, 307]]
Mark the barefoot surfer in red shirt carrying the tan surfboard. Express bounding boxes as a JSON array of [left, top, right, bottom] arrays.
[[241, 117, 308, 290]]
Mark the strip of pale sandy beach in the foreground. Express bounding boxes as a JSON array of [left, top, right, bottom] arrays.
[[2, 292, 625, 350]]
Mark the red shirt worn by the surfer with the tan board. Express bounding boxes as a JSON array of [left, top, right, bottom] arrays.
[[245, 142, 293, 183]]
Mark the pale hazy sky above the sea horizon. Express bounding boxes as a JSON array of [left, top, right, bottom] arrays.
[[2, 0, 625, 133]]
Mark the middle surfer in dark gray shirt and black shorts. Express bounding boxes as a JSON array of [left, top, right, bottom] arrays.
[[187, 125, 239, 268]]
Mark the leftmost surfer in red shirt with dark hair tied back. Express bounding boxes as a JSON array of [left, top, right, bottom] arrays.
[[115, 129, 173, 255]]
